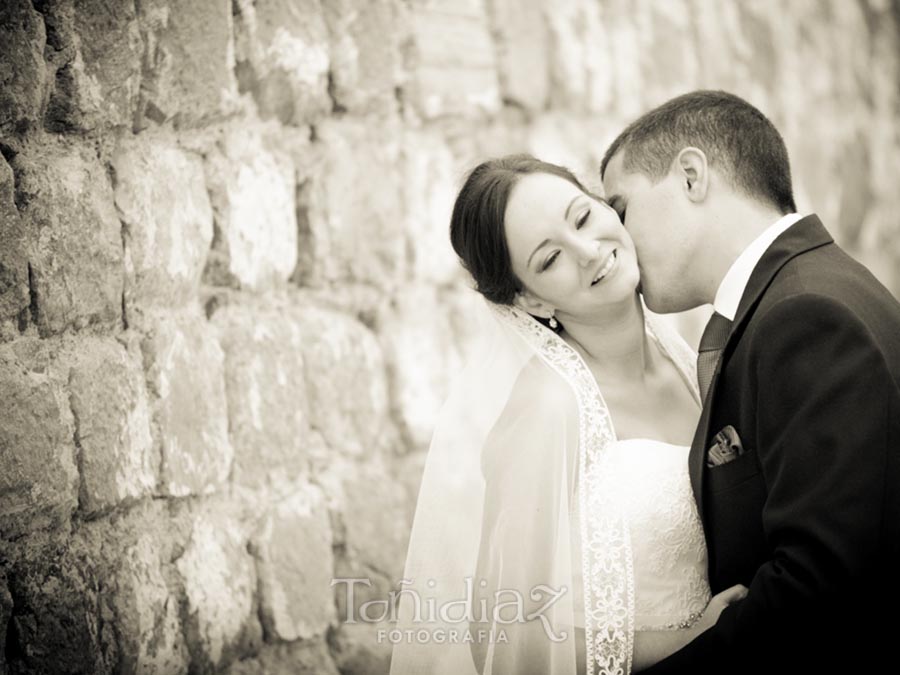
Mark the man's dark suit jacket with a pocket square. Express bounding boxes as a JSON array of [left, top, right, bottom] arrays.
[[645, 216, 900, 675]]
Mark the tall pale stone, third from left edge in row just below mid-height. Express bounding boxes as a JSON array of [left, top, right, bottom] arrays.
[[141, 310, 234, 497]]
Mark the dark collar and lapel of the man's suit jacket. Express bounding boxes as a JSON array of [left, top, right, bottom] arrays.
[[688, 214, 833, 526]]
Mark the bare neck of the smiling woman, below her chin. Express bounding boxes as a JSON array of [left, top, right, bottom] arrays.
[[562, 293, 648, 380]]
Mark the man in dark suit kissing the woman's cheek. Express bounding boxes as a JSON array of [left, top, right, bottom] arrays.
[[601, 91, 900, 675]]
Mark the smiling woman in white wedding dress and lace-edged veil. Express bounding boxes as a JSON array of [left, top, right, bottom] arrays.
[[391, 155, 746, 675]]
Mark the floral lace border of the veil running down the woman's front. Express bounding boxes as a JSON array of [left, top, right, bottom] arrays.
[[491, 305, 632, 675]]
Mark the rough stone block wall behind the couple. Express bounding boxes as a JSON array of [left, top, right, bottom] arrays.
[[0, 0, 900, 674]]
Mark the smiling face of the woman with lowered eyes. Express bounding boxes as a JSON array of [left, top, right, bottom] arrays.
[[504, 173, 639, 323]]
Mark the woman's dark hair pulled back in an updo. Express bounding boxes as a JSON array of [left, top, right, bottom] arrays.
[[450, 154, 591, 305]]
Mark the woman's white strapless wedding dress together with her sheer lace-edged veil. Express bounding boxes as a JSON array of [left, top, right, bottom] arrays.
[[391, 305, 710, 675]]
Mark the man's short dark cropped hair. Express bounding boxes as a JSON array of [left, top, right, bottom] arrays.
[[600, 90, 797, 213]]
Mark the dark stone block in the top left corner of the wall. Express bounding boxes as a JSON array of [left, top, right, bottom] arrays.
[[0, 0, 47, 135]]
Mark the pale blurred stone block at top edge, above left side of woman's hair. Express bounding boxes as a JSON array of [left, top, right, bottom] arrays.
[[410, 0, 501, 118]]
